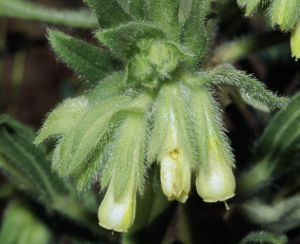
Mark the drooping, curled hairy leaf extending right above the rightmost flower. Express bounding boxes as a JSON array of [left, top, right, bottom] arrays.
[[199, 67, 288, 112]]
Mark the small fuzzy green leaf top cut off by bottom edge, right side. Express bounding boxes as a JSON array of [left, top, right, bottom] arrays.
[[240, 231, 288, 244]]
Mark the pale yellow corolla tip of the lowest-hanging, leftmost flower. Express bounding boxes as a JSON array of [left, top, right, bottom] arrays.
[[98, 177, 136, 232]]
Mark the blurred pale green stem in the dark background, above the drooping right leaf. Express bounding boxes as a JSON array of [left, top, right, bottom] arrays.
[[212, 32, 287, 64]]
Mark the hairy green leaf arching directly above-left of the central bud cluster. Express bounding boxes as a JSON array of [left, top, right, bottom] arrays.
[[96, 22, 165, 61]]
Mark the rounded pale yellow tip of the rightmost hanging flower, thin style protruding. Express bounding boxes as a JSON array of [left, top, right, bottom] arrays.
[[196, 145, 235, 202]]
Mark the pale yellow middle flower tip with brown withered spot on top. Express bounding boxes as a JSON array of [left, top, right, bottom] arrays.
[[160, 149, 191, 203]]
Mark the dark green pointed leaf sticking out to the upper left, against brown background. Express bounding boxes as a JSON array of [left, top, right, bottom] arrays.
[[48, 30, 117, 83]]
